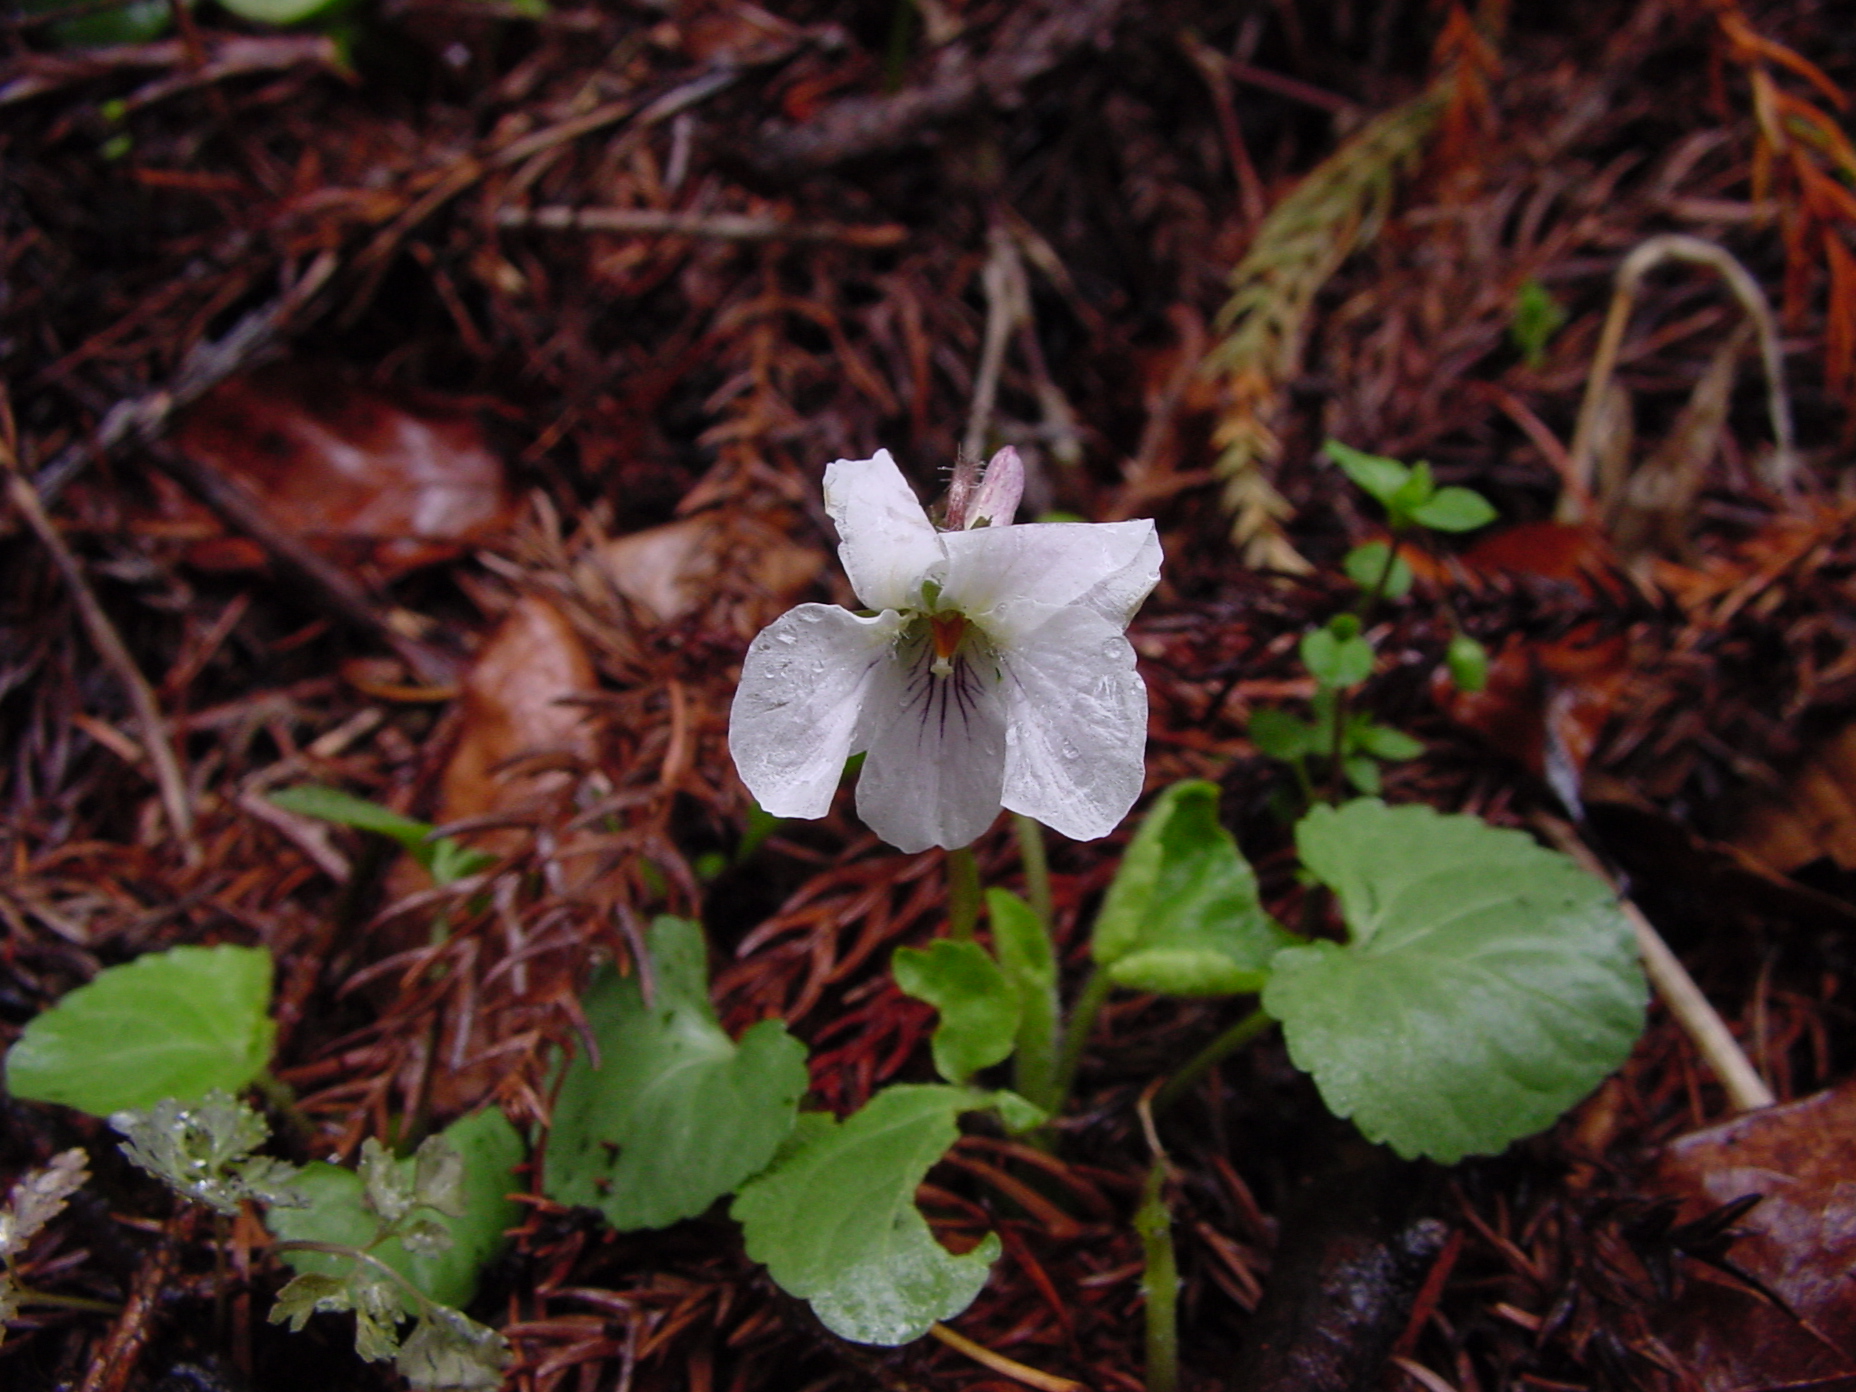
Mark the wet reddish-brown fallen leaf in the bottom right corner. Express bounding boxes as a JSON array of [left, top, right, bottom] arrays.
[[1656, 1082, 1856, 1392]]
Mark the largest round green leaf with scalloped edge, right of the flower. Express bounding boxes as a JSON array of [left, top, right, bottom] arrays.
[[1264, 800, 1644, 1164]]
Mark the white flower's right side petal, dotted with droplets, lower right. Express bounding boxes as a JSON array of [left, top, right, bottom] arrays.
[[1000, 607, 1147, 841]]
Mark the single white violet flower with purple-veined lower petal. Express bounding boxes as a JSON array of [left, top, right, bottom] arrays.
[[728, 449, 1160, 850]]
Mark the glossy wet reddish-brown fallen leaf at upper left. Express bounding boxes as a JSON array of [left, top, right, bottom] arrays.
[[163, 362, 516, 577]]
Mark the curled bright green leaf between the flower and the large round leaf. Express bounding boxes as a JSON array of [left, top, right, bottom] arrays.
[[1089, 781, 1295, 995]]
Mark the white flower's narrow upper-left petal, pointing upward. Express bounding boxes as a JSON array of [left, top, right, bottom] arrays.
[[824, 449, 947, 609]]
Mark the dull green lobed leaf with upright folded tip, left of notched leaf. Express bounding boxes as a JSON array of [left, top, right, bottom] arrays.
[[542, 917, 807, 1231]]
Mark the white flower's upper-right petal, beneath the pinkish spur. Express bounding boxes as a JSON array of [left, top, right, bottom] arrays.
[[941, 518, 1160, 644]]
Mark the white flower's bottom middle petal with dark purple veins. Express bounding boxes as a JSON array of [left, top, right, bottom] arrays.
[[857, 650, 1006, 850]]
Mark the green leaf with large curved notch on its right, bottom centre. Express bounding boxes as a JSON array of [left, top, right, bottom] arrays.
[[731, 1086, 1000, 1346]]
